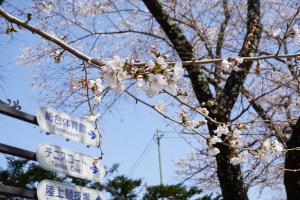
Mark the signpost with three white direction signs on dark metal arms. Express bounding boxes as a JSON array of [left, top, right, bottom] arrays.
[[0, 101, 105, 200]]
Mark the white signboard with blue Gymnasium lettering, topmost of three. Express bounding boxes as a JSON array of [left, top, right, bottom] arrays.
[[37, 107, 100, 147]]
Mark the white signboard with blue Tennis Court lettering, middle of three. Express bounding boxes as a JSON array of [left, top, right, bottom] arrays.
[[36, 144, 104, 181]]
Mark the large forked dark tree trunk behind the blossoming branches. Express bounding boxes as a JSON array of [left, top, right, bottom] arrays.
[[143, 0, 261, 200]]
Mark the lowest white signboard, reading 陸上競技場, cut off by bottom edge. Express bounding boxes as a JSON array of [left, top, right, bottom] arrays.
[[37, 180, 104, 200]]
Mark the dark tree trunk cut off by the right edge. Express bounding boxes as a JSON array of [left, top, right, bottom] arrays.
[[284, 117, 300, 200]]
